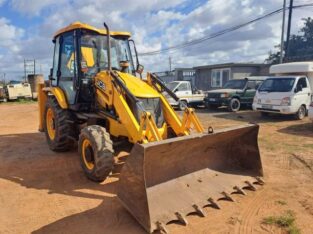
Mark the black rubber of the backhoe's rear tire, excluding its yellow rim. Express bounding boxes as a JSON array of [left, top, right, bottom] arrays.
[[44, 96, 74, 152]]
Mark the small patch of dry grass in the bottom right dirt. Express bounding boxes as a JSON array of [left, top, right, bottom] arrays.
[[262, 210, 301, 234]]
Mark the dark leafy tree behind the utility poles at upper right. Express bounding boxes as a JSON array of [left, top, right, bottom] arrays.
[[265, 17, 313, 64]]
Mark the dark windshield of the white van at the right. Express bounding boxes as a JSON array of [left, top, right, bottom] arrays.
[[259, 77, 295, 92]]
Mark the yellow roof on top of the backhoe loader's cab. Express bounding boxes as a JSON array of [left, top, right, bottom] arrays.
[[53, 21, 131, 38]]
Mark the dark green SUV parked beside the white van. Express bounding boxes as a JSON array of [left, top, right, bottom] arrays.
[[204, 77, 266, 111]]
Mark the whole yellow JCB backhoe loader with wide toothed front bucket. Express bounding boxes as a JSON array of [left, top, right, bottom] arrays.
[[38, 22, 263, 233]]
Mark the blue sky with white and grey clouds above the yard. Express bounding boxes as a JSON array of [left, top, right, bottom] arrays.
[[0, 0, 313, 80]]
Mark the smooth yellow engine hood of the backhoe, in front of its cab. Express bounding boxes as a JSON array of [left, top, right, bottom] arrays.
[[117, 72, 160, 98]]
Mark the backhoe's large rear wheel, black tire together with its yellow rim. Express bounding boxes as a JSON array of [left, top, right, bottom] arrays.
[[44, 97, 74, 152]]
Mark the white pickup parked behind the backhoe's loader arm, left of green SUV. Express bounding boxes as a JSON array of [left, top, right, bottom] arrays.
[[165, 81, 205, 110]]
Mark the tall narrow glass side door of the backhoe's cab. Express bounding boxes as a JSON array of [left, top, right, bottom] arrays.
[[57, 32, 77, 105]]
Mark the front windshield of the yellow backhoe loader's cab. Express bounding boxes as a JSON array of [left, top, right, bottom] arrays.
[[80, 31, 135, 76]]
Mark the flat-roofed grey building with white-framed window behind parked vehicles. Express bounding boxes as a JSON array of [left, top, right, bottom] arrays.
[[194, 63, 270, 90]]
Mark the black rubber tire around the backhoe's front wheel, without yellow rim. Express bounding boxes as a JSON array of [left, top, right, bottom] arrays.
[[78, 125, 114, 182]]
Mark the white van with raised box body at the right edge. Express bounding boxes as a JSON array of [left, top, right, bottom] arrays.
[[252, 62, 313, 119]]
